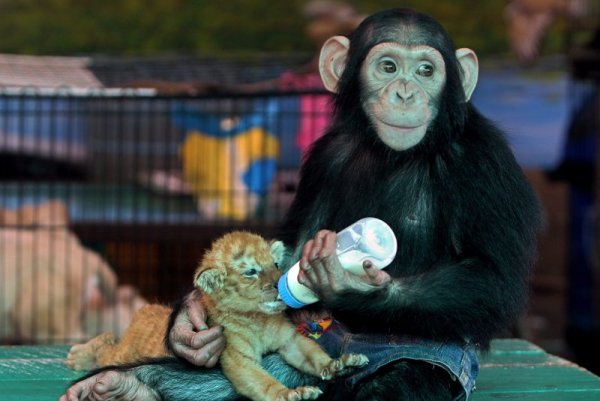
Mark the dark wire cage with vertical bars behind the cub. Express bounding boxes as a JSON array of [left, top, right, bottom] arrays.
[[0, 88, 330, 343]]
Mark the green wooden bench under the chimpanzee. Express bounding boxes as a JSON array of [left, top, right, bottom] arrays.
[[0, 339, 600, 401]]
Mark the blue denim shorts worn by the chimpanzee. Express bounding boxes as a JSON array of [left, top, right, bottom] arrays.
[[316, 321, 479, 400]]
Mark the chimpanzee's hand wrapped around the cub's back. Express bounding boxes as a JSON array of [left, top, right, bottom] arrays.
[[169, 290, 225, 368]]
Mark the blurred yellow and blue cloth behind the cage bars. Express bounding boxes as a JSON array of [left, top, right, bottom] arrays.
[[173, 102, 280, 220]]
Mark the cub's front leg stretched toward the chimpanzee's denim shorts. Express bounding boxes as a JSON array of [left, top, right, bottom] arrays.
[[279, 326, 369, 380]]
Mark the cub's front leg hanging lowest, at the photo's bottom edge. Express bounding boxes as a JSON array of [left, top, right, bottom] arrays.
[[220, 347, 323, 401]]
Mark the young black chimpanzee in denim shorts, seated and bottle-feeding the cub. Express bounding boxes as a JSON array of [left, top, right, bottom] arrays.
[[59, 9, 541, 401]]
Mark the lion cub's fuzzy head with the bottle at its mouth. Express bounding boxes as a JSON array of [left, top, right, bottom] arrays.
[[194, 231, 285, 314]]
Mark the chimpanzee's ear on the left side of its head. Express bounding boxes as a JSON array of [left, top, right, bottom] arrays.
[[319, 36, 350, 93]]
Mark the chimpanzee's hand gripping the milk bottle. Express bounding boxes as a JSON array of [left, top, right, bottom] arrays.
[[298, 230, 391, 301]]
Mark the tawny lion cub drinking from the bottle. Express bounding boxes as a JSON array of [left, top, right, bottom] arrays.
[[67, 231, 368, 401]]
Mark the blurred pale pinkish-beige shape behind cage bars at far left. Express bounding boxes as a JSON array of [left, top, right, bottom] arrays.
[[0, 201, 146, 343]]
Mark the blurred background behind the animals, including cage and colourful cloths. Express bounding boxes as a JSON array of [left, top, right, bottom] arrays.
[[0, 0, 600, 373]]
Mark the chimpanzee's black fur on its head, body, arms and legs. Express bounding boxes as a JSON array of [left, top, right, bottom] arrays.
[[68, 9, 541, 401]]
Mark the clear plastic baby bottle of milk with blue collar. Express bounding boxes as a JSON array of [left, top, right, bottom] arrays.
[[278, 217, 398, 308]]
